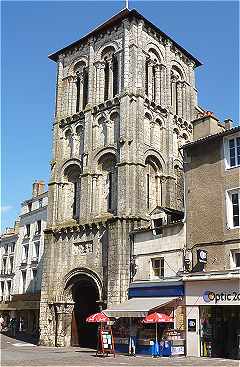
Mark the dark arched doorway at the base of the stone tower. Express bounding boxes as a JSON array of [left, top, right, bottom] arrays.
[[71, 275, 99, 348]]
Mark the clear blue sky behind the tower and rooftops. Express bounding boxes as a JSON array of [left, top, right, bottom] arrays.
[[1, 0, 239, 228]]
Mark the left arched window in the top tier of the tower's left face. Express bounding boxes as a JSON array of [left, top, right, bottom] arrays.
[[74, 61, 88, 112]]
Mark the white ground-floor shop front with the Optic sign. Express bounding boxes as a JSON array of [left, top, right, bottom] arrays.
[[184, 274, 240, 359]]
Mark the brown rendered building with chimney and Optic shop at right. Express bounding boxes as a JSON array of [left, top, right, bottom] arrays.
[[183, 113, 240, 358]]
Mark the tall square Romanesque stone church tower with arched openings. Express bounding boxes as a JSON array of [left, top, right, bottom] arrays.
[[40, 9, 200, 346]]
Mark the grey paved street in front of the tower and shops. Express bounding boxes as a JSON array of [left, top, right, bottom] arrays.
[[0, 334, 239, 367]]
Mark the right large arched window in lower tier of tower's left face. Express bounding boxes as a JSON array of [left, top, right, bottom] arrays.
[[98, 154, 117, 212]]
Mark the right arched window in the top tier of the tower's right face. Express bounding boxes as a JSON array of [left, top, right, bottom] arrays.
[[171, 66, 183, 117]]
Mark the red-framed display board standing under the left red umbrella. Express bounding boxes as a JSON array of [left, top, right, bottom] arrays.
[[96, 324, 115, 358]]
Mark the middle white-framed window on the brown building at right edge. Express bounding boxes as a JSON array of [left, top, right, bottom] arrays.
[[227, 189, 240, 228]]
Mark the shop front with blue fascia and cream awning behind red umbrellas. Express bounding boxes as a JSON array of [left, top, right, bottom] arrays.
[[103, 282, 185, 356]]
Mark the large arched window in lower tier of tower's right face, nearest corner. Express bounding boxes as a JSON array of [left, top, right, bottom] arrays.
[[145, 156, 162, 210]]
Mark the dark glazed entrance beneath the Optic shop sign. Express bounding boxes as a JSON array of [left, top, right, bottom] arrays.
[[200, 306, 240, 359]]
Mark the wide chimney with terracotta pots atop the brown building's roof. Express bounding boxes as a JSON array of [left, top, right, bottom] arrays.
[[192, 111, 224, 140]]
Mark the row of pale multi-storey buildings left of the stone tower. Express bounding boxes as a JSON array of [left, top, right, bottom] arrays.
[[0, 181, 48, 333]]
